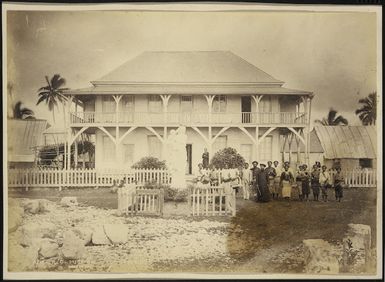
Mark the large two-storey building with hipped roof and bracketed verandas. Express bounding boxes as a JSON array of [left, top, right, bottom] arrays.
[[65, 51, 312, 174]]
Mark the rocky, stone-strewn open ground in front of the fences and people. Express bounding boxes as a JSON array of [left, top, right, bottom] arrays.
[[9, 186, 376, 273]]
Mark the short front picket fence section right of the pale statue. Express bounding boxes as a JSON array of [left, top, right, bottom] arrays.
[[188, 186, 236, 216]]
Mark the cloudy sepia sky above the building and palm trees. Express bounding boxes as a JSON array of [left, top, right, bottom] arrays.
[[7, 7, 378, 125]]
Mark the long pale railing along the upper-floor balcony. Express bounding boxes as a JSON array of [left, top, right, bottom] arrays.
[[70, 112, 307, 125]]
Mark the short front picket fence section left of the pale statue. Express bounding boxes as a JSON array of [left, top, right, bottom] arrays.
[[118, 186, 164, 215]]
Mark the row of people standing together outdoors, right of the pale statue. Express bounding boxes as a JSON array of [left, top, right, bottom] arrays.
[[196, 161, 344, 202]]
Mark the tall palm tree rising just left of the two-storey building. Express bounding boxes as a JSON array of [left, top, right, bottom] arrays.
[[36, 74, 68, 123]]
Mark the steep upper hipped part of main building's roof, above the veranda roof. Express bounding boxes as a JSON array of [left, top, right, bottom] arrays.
[[95, 51, 282, 84]]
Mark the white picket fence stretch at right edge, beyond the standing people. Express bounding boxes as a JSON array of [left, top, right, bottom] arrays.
[[331, 168, 377, 188]]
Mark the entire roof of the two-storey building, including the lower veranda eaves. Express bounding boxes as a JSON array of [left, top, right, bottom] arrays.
[[65, 51, 311, 95]]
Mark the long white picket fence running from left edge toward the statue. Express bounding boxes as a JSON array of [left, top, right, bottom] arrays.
[[8, 168, 171, 188]]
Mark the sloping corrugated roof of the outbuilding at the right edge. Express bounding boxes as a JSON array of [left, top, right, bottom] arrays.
[[314, 126, 377, 159]]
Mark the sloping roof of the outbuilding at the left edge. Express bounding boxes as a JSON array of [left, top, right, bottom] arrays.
[[7, 119, 47, 162]]
